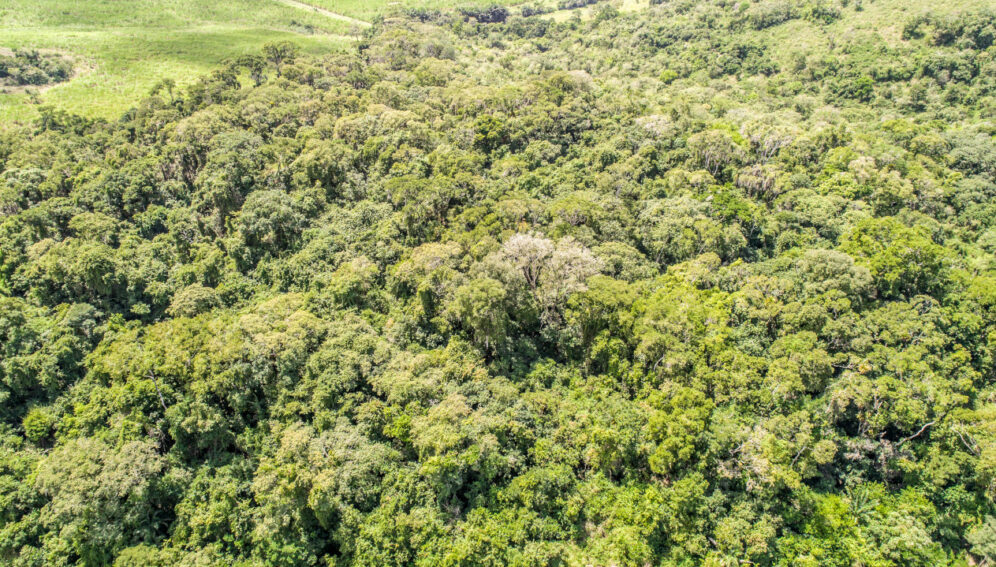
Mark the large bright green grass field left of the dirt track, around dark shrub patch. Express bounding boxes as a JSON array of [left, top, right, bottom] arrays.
[[0, 0, 358, 123]]
